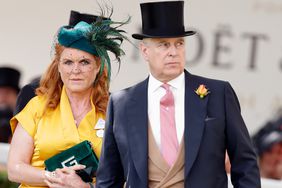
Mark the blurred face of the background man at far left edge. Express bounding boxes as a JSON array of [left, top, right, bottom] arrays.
[[0, 87, 17, 110]]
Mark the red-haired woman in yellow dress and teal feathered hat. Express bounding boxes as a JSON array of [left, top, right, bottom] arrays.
[[8, 10, 129, 188]]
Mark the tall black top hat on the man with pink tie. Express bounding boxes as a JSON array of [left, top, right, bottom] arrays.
[[132, 1, 196, 40]]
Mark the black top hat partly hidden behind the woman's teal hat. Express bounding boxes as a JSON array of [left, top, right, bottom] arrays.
[[69, 10, 98, 26]]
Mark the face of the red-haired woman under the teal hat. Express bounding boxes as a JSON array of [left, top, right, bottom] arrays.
[[57, 48, 100, 93]]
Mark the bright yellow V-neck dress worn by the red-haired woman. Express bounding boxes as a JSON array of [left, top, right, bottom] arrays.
[[10, 87, 105, 188]]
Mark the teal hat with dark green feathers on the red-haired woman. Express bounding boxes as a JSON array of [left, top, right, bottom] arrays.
[[58, 16, 130, 79]]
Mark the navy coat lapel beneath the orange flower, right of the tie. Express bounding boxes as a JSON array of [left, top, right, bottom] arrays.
[[184, 71, 209, 177]]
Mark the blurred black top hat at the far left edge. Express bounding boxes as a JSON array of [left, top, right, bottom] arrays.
[[0, 67, 21, 92]]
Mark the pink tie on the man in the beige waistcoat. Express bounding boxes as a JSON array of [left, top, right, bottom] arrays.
[[160, 84, 179, 166]]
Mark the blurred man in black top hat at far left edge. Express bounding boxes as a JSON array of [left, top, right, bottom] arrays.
[[0, 67, 20, 143]]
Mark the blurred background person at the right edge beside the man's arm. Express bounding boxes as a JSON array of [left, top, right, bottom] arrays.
[[253, 117, 282, 180]]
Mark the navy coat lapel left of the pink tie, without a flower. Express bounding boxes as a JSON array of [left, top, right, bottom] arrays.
[[126, 79, 148, 185]]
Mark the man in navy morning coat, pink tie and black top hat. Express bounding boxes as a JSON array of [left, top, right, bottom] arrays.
[[97, 1, 260, 188]]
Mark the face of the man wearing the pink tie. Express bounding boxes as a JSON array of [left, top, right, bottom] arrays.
[[140, 37, 185, 82]]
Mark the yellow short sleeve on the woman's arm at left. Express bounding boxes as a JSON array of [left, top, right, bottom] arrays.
[[10, 97, 44, 137]]
